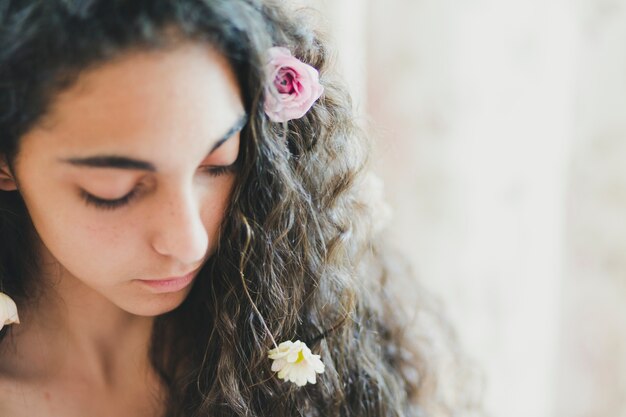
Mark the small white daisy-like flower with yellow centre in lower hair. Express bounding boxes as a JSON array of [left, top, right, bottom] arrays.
[[268, 340, 324, 387]]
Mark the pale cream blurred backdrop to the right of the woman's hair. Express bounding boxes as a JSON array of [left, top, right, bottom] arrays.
[[293, 0, 626, 417]]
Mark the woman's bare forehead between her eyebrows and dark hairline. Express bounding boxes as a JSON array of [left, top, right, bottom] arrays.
[[21, 43, 243, 164]]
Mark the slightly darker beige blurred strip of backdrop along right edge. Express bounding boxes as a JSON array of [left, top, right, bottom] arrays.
[[556, 0, 626, 417]]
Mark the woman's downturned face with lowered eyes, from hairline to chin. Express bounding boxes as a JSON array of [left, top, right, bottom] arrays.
[[7, 44, 245, 315]]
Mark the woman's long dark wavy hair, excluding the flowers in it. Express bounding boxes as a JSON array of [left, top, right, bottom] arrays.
[[0, 0, 472, 417]]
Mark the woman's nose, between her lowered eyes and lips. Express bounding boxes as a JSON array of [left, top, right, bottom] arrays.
[[152, 185, 209, 264]]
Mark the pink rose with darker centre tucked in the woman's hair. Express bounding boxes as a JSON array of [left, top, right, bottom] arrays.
[[264, 47, 324, 122]]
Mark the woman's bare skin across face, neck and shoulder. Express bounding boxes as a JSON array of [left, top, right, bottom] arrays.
[[0, 43, 245, 417]]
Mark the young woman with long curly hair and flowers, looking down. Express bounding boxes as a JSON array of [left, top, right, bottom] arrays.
[[0, 0, 456, 417]]
